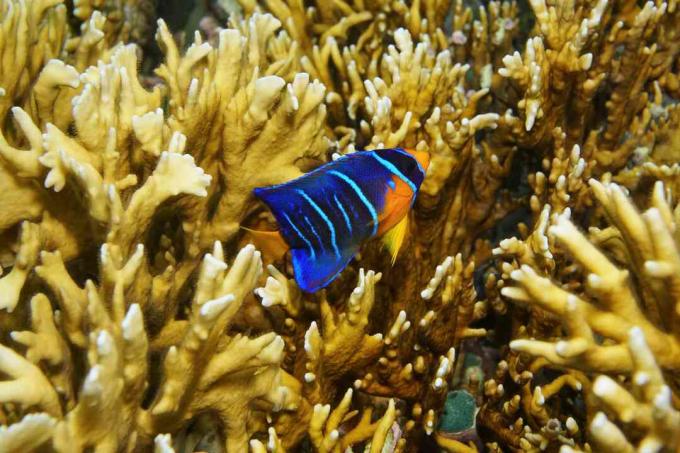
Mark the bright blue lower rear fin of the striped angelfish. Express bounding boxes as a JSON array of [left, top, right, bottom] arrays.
[[292, 248, 357, 293]]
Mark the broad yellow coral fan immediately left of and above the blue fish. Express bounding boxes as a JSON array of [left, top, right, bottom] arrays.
[[157, 15, 327, 249]]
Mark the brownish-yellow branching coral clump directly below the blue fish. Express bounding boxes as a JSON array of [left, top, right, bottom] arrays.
[[258, 255, 486, 445]]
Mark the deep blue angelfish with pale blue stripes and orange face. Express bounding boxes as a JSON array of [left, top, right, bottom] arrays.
[[254, 148, 429, 292]]
